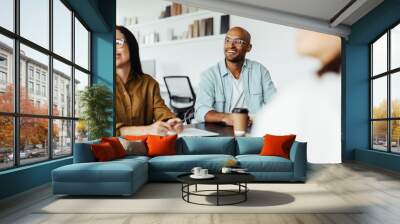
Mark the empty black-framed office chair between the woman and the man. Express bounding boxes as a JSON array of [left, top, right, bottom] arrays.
[[164, 76, 196, 124]]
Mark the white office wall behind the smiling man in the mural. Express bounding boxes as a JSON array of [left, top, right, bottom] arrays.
[[117, 0, 318, 89]]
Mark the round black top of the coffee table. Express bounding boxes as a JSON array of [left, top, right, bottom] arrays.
[[177, 173, 255, 184]]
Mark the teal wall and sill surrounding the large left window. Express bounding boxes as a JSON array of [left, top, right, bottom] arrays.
[[0, 0, 116, 199]]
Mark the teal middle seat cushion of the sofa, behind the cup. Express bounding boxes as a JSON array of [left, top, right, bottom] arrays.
[[149, 154, 235, 172]]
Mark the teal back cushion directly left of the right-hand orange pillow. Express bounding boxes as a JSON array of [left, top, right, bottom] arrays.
[[236, 137, 264, 155]]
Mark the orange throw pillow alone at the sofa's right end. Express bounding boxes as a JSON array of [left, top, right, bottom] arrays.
[[260, 134, 296, 159]]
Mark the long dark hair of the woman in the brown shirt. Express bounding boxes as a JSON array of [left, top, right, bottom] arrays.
[[117, 26, 143, 75]]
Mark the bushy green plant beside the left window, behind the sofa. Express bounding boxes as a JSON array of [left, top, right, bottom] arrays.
[[79, 84, 113, 140]]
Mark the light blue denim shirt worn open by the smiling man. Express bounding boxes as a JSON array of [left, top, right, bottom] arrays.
[[195, 59, 276, 122]]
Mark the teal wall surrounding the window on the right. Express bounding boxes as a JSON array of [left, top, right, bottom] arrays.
[[342, 0, 400, 170]]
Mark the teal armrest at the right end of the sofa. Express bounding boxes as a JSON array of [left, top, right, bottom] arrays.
[[290, 142, 307, 181]]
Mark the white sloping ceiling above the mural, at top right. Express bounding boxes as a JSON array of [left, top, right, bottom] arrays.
[[169, 0, 383, 37]]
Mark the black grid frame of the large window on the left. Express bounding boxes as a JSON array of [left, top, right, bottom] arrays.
[[0, 0, 93, 172]]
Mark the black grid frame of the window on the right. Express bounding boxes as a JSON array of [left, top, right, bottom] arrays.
[[368, 21, 400, 155]]
